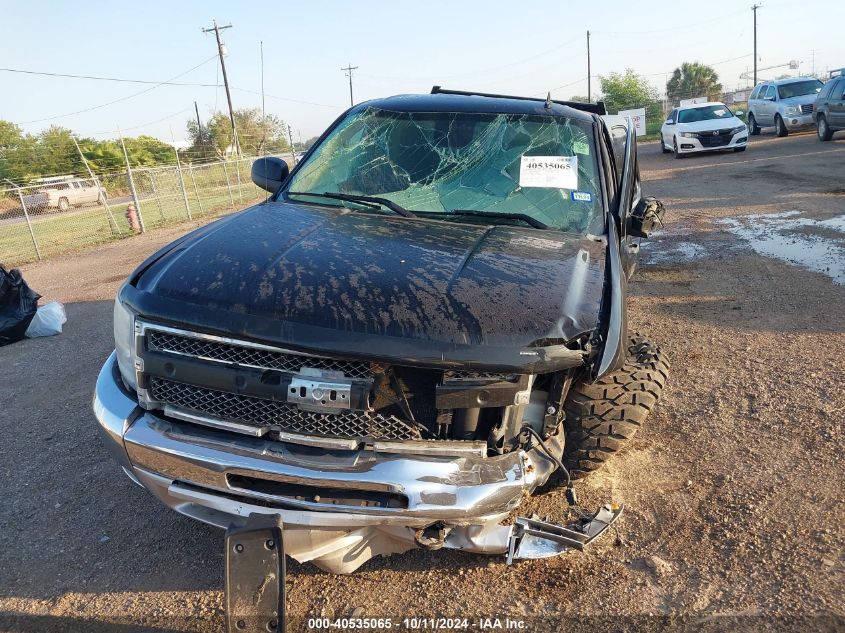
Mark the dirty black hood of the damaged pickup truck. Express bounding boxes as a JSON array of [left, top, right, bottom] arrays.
[[126, 202, 606, 362]]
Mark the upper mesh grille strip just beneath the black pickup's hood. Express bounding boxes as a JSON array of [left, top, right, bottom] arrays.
[[147, 328, 372, 380]]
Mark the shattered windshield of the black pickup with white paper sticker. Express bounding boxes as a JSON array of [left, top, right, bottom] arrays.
[[286, 107, 603, 233]]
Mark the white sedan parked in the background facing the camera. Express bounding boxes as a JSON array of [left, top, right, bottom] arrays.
[[660, 101, 748, 158]]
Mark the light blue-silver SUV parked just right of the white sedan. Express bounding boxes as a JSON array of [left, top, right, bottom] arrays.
[[748, 77, 824, 136]]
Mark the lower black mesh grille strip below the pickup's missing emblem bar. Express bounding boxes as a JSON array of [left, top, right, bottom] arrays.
[[149, 376, 421, 440]]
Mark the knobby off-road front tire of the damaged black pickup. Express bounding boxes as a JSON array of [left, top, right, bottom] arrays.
[[563, 334, 669, 479]]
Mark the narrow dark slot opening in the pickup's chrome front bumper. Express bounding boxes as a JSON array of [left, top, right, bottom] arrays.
[[226, 474, 408, 508]]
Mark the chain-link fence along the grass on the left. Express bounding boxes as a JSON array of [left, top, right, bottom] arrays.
[[0, 158, 286, 267]]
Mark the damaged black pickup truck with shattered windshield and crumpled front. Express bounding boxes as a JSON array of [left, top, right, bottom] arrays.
[[94, 88, 667, 572]]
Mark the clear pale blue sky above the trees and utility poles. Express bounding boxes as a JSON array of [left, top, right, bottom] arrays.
[[0, 0, 845, 142]]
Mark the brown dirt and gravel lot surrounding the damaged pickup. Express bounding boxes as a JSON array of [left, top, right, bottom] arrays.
[[0, 135, 845, 632]]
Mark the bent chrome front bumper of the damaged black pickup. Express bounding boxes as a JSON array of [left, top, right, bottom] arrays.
[[93, 354, 619, 572]]
